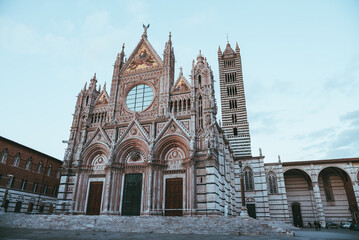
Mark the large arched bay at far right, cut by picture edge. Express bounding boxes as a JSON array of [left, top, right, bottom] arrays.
[[318, 167, 358, 223]]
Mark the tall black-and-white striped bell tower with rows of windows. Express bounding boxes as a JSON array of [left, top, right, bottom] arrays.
[[218, 42, 252, 157]]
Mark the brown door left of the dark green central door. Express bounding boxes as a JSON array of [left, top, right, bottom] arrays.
[[86, 182, 103, 215]]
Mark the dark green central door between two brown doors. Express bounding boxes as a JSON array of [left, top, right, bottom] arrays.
[[122, 173, 142, 216]]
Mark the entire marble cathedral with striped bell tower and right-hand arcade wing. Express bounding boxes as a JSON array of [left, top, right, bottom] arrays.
[[57, 26, 359, 226]]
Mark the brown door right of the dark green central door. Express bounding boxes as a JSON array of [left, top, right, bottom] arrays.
[[165, 178, 183, 216]]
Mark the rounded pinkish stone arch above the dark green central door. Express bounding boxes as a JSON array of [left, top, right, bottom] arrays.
[[115, 137, 149, 163]]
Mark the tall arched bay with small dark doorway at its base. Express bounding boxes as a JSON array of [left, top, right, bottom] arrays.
[[284, 169, 318, 227]]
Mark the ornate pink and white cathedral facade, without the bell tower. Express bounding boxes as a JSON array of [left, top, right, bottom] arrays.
[[58, 28, 240, 215]]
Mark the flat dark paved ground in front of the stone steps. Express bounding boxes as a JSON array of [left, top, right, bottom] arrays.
[[0, 227, 359, 240]]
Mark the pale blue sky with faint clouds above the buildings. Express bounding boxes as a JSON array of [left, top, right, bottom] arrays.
[[0, 0, 359, 162]]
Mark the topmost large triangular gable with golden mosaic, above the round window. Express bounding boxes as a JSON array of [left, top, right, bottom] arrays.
[[123, 36, 162, 73]]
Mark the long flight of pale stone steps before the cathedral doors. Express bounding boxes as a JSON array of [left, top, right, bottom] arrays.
[[0, 213, 295, 236]]
